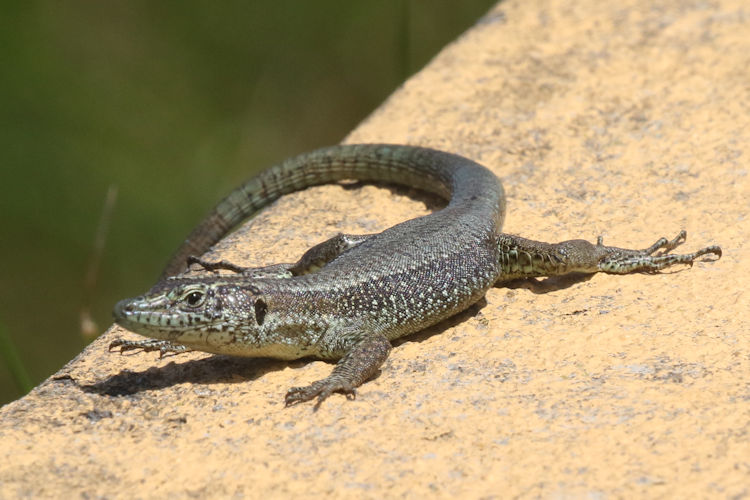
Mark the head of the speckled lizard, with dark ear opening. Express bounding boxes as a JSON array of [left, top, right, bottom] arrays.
[[113, 278, 267, 346]]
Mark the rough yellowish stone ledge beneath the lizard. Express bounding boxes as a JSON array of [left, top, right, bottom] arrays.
[[0, 0, 750, 498]]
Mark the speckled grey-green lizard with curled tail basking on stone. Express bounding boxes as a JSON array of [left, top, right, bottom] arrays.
[[109, 144, 721, 409]]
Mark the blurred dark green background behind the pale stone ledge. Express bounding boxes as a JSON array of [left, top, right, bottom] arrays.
[[0, 0, 494, 403]]
